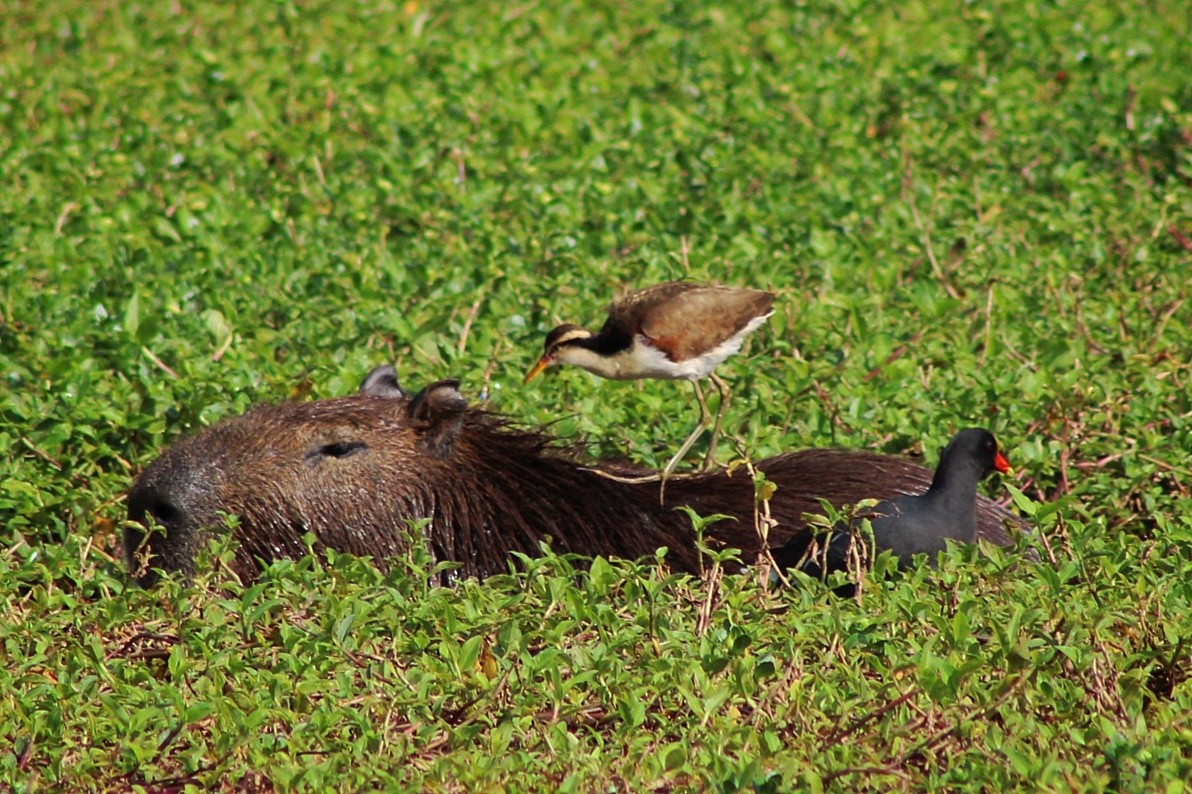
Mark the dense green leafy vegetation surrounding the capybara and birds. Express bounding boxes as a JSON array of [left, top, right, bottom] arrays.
[[0, 0, 1192, 792]]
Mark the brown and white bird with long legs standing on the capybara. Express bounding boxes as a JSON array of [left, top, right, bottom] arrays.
[[524, 276, 774, 489]]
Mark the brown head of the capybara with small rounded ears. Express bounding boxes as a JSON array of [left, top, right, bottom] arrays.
[[124, 367, 431, 582]]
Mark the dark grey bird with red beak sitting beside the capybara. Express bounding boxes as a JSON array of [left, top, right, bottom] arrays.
[[774, 428, 1012, 576]]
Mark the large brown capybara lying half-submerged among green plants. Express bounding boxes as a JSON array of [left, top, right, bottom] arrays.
[[124, 366, 1017, 584]]
